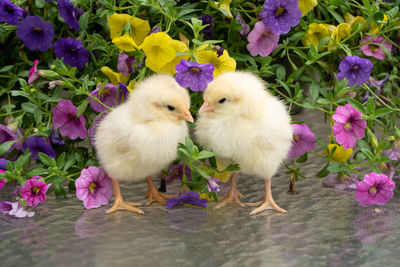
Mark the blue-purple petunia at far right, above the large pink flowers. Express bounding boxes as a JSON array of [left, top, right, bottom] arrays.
[[337, 56, 374, 86]]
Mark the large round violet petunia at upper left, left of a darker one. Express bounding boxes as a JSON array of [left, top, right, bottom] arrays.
[[17, 16, 54, 51]]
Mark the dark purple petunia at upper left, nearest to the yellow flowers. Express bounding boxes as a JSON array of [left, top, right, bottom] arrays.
[[54, 37, 89, 68]]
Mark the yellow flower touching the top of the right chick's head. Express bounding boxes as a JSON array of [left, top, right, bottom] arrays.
[[196, 45, 236, 77]]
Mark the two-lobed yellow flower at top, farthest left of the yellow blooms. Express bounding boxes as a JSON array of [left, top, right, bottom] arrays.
[[107, 13, 150, 45]]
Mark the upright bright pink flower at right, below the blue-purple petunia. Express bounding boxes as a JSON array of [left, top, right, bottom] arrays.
[[332, 104, 367, 149]]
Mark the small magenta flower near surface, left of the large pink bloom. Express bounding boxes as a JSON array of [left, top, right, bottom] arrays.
[[19, 176, 49, 206]]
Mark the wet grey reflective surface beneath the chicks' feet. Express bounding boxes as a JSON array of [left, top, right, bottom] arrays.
[[0, 110, 400, 266]]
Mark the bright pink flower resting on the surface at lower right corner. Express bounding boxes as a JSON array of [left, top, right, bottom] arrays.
[[354, 172, 395, 206]]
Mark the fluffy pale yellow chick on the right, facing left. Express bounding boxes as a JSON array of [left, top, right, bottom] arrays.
[[196, 72, 292, 214]]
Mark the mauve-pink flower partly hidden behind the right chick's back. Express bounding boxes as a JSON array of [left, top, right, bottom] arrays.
[[287, 124, 315, 158]]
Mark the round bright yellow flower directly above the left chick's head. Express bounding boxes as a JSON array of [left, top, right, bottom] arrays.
[[141, 32, 176, 72]]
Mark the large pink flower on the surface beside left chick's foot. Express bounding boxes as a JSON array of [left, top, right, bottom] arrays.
[[75, 166, 113, 209]]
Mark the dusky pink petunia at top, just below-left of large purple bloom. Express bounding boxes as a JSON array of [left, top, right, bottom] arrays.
[[246, 21, 279, 57]]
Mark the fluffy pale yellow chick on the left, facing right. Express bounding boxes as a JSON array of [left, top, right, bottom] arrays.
[[96, 75, 193, 214]]
